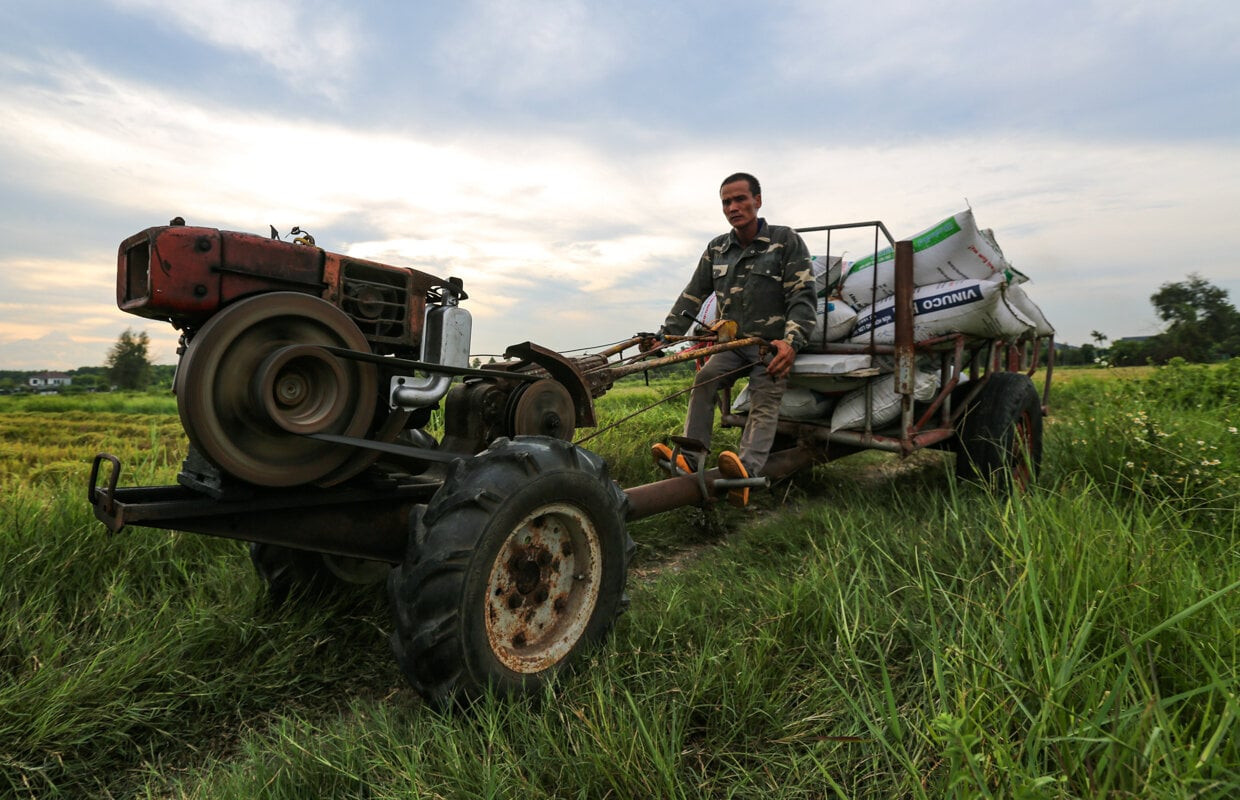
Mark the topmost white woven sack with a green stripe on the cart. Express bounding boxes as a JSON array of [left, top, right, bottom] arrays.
[[841, 208, 1028, 308]]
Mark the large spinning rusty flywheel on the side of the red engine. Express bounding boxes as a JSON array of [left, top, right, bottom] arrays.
[[175, 291, 377, 486]]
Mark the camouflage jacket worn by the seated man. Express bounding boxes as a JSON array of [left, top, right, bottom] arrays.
[[662, 220, 815, 350]]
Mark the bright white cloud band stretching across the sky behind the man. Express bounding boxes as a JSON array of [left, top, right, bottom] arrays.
[[0, 45, 1240, 367]]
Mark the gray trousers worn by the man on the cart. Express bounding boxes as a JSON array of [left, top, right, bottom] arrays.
[[684, 345, 787, 475]]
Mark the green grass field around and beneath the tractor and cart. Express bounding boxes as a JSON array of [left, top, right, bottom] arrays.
[[0, 367, 1240, 799]]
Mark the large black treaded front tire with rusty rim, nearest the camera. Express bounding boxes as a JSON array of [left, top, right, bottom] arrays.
[[388, 437, 634, 707]]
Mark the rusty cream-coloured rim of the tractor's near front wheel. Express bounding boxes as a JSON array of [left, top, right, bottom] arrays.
[[485, 504, 603, 675]]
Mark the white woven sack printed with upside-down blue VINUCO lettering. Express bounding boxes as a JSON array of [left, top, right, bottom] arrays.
[[848, 280, 1035, 345]]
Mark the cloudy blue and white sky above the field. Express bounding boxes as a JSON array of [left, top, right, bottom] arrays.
[[0, 0, 1240, 368]]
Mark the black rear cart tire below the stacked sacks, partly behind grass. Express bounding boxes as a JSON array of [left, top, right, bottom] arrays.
[[956, 372, 1042, 491]]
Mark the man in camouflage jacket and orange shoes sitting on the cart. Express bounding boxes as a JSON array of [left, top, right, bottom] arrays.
[[651, 172, 815, 505]]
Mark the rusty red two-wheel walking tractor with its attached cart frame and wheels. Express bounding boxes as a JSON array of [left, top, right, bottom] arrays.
[[88, 220, 1049, 703]]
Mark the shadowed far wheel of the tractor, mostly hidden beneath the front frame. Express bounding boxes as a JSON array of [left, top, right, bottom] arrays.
[[249, 542, 392, 605]]
